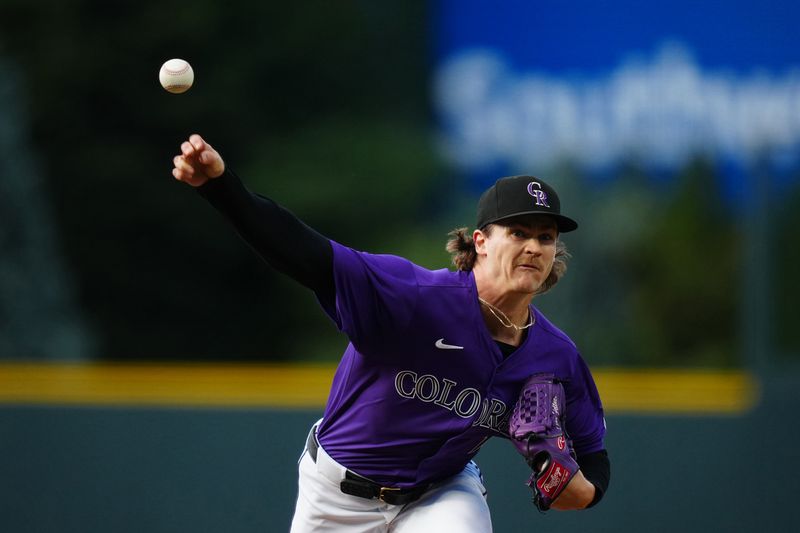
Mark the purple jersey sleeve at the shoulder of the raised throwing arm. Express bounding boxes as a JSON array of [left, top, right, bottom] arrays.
[[321, 241, 419, 353]]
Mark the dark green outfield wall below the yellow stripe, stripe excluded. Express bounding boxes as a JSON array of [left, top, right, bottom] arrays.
[[0, 377, 800, 533]]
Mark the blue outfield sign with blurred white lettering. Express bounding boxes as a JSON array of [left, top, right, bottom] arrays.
[[433, 0, 800, 180]]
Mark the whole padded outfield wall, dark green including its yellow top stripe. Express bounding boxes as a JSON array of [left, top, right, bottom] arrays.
[[0, 364, 800, 533]]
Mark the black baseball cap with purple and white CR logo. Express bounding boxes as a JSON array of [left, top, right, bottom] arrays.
[[476, 176, 578, 233]]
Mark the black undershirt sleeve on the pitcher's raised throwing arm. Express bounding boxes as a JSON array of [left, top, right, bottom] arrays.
[[197, 169, 335, 306]]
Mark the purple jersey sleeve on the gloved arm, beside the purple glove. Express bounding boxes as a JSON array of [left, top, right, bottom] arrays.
[[564, 355, 606, 456]]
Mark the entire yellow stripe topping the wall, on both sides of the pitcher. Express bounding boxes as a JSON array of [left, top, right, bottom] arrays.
[[0, 363, 759, 414]]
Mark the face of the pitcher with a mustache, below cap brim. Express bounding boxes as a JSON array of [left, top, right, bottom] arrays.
[[473, 215, 558, 295]]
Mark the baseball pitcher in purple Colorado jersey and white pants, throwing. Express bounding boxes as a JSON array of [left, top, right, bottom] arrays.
[[172, 135, 610, 533]]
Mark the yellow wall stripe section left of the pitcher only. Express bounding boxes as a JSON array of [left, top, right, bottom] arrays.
[[0, 363, 334, 408]]
